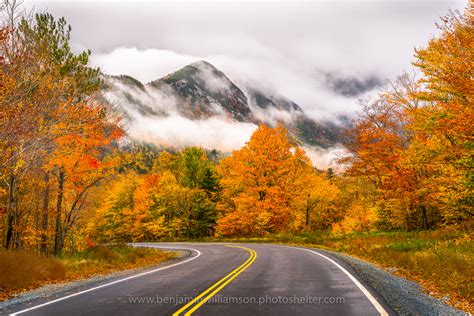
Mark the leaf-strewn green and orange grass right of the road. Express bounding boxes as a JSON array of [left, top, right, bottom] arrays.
[[208, 224, 474, 314]]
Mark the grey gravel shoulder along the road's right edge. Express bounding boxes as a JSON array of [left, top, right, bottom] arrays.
[[315, 249, 468, 316]]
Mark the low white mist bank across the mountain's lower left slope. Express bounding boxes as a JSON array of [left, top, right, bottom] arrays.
[[104, 73, 257, 152]]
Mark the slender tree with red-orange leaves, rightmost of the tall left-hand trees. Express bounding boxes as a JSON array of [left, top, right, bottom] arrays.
[[47, 104, 122, 255]]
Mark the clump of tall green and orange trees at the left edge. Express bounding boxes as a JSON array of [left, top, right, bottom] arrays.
[[0, 6, 121, 254]]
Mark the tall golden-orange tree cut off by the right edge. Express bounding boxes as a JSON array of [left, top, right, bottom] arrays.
[[410, 8, 474, 223]]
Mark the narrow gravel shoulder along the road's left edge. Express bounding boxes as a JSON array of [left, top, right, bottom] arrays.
[[0, 250, 191, 314]]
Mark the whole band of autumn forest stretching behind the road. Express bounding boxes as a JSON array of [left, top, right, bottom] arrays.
[[0, 1, 474, 312]]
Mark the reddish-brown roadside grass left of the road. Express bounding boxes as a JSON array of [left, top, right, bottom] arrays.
[[0, 244, 177, 301]]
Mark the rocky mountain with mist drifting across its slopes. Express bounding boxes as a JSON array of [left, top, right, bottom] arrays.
[[104, 61, 340, 147]]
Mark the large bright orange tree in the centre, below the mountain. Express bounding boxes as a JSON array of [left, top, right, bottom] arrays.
[[216, 125, 309, 235]]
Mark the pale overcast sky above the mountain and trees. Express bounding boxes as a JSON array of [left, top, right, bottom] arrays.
[[26, 0, 468, 118]]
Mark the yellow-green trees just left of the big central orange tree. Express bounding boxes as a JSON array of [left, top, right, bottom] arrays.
[[90, 147, 219, 241]]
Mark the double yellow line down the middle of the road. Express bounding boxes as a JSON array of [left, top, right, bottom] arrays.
[[173, 246, 257, 316]]
